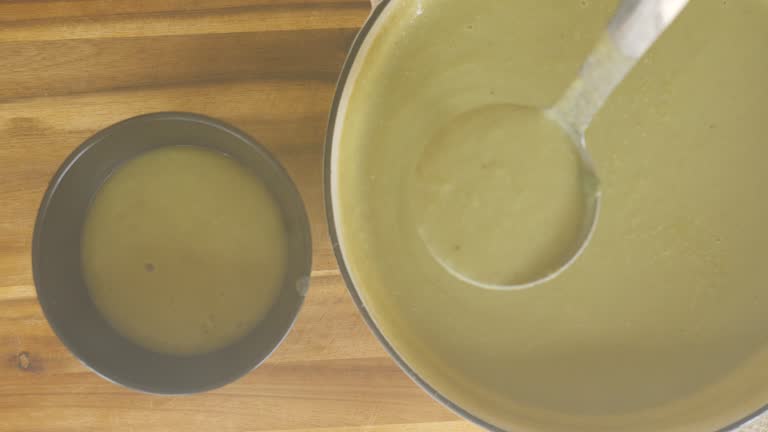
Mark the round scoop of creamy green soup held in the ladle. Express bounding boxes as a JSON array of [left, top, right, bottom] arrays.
[[408, 104, 596, 287]]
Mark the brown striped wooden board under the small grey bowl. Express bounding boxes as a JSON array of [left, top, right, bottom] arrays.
[[0, 0, 477, 432]]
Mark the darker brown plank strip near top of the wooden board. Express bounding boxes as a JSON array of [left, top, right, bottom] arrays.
[[0, 29, 356, 101]]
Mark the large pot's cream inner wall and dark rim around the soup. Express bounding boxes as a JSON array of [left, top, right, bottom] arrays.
[[324, 0, 768, 431]]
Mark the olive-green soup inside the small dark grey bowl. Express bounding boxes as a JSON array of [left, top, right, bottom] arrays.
[[81, 146, 286, 355]]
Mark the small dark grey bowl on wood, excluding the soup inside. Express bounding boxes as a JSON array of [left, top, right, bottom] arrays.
[[32, 113, 312, 394]]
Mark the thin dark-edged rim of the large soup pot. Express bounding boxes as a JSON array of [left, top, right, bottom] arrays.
[[323, 0, 768, 432]]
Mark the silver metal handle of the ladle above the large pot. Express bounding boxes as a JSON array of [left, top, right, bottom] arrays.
[[548, 0, 689, 141]]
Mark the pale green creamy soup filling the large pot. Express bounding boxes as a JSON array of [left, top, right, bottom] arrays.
[[333, 0, 768, 431]]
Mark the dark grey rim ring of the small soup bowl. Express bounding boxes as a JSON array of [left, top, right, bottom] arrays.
[[31, 111, 313, 396]]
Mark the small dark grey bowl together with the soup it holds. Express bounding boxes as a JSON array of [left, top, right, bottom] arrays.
[[32, 112, 312, 394]]
